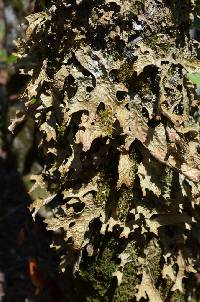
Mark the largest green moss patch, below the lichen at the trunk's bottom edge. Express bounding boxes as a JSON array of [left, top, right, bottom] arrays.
[[79, 238, 139, 302]]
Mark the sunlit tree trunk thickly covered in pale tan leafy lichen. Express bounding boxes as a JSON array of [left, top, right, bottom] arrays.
[[10, 0, 200, 302]]
